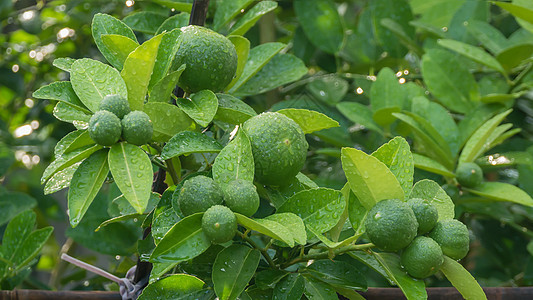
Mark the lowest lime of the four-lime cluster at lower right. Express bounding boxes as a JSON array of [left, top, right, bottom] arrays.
[[401, 236, 444, 279]]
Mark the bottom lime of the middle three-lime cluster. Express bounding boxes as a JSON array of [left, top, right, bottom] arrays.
[[202, 205, 237, 244]]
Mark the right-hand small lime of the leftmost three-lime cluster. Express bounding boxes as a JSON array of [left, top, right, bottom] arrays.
[[122, 110, 154, 146]]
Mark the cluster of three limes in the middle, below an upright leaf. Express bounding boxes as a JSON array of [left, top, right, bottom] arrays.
[[173, 175, 259, 244]]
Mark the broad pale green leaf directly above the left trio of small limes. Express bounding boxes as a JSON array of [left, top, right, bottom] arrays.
[[70, 58, 128, 112]]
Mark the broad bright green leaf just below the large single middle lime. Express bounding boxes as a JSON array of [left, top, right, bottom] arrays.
[[277, 188, 346, 236]]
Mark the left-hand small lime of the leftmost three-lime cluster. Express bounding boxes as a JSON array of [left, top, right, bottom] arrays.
[[88, 110, 122, 146]]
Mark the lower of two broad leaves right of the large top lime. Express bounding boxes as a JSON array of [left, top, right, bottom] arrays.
[[235, 54, 307, 96]]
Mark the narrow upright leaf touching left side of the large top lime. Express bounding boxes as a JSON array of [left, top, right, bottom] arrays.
[[148, 28, 183, 91]]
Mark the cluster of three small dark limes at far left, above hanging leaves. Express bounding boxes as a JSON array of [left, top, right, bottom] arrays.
[[88, 95, 154, 146]]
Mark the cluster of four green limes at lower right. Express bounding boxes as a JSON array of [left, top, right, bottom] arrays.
[[365, 198, 470, 278]]
